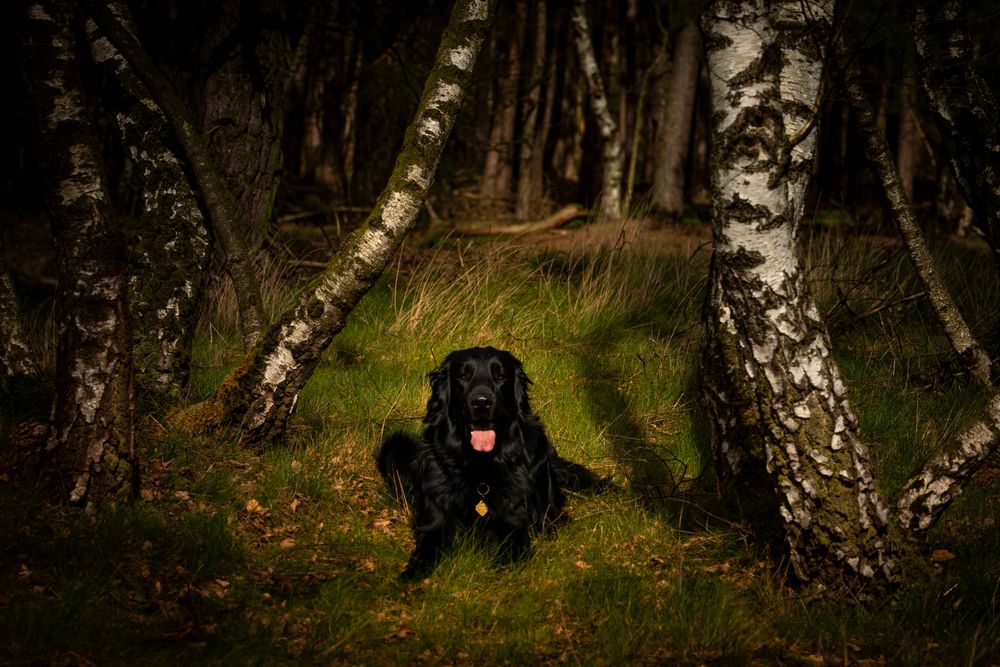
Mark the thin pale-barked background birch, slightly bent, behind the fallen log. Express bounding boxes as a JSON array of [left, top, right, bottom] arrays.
[[571, 0, 622, 218]]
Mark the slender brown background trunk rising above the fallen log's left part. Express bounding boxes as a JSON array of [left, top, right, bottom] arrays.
[[514, 0, 548, 220]]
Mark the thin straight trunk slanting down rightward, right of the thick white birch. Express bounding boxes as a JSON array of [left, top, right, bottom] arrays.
[[840, 52, 991, 387]]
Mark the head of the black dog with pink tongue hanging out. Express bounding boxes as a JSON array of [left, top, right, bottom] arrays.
[[424, 347, 531, 454]]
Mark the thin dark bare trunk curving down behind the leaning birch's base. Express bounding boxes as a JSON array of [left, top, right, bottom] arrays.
[[84, 0, 265, 347]]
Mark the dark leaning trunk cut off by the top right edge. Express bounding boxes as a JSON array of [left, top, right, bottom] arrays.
[[913, 0, 1000, 272]]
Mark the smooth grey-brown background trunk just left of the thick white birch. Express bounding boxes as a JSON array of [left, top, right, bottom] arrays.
[[652, 21, 701, 220]]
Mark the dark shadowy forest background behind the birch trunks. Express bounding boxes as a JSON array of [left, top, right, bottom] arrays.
[[0, 0, 998, 293]]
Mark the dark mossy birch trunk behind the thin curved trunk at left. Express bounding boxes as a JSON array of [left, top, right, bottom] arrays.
[[87, 2, 210, 402]]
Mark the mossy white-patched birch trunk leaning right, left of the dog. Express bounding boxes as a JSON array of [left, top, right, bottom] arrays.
[[173, 0, 496, 441]]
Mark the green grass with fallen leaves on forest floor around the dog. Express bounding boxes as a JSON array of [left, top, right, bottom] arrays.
[[0, 231, 1000, 665]]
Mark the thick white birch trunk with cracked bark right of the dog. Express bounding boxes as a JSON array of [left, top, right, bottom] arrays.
[[702, 0, 897, 594]]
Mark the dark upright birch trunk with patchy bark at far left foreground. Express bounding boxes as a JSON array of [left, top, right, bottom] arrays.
[[24, 0, 138, 503]]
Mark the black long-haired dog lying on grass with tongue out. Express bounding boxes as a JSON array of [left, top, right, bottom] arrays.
[[376, 347, 604, 579]]
